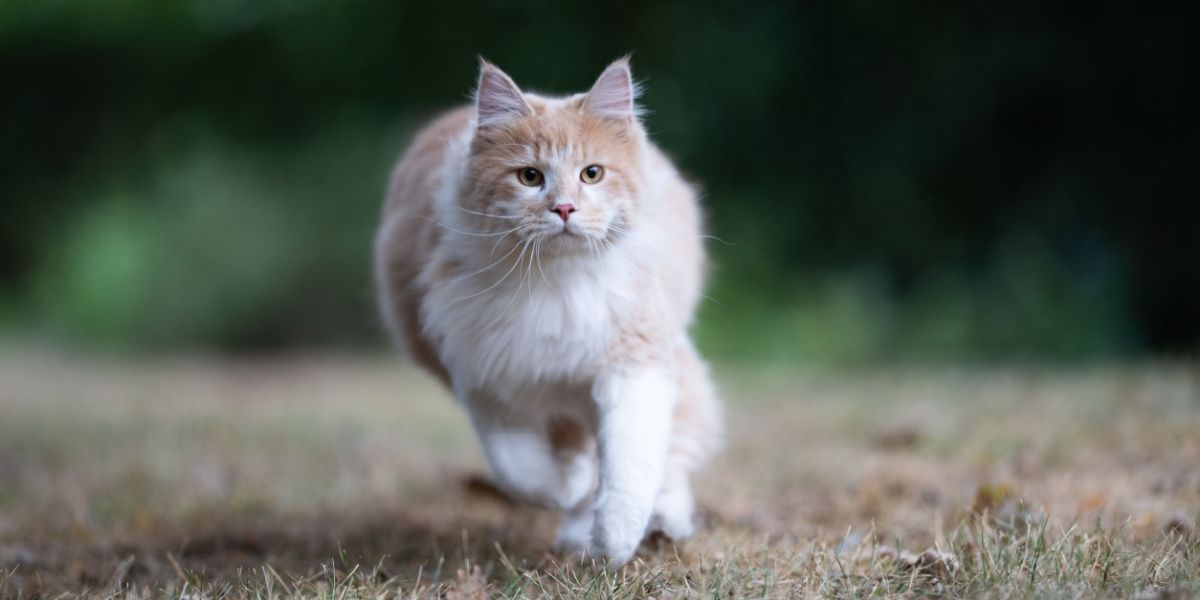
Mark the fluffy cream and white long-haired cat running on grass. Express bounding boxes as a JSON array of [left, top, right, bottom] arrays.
[[376, 58, 721, 565]]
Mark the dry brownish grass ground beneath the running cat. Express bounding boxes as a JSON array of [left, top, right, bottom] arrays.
[[0, 352, 1200, 598]]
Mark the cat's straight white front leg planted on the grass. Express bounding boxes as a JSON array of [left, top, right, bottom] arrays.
[[593, 366, 677, 565]]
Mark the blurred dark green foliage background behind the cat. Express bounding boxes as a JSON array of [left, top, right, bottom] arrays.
[[0, 0, 1200, 364]]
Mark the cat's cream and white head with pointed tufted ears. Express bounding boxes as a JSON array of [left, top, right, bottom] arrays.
[[460, 59, 646, 253]]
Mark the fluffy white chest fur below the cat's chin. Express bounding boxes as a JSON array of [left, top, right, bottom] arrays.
[[422, 247, 636, 396]]
